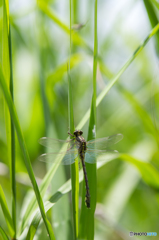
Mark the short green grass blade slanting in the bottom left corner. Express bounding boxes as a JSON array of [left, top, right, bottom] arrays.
[[0, 186, 14, 236]]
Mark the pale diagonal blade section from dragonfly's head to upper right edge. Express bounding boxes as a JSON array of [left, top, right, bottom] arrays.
[[77, 24, 159, 129]]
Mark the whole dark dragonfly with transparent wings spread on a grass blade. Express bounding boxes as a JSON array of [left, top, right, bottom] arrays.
[[39, 130, 123, 208]]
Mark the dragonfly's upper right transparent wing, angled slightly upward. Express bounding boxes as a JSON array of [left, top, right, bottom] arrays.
[[87, 133, 123, 150]]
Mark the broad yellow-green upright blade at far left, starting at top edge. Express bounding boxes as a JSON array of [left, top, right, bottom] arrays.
[[1, 0, 16, 238]]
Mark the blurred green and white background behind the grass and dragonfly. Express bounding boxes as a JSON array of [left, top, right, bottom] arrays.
[[0, 0, 159, 240]]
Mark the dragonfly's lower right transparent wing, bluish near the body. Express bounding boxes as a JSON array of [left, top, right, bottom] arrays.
[[85, 149, 118, 163]]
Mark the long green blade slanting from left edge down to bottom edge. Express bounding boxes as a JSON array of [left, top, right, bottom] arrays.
[[0, 66, 55, 239]]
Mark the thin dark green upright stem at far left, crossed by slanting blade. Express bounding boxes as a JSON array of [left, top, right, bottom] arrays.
[[9, 24, 16, 239]]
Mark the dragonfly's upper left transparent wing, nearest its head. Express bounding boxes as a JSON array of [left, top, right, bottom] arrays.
[[39, 137, 74, 152]]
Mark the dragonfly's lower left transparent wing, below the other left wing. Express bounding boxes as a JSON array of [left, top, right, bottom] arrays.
[[38, 149, 78, 165]]
